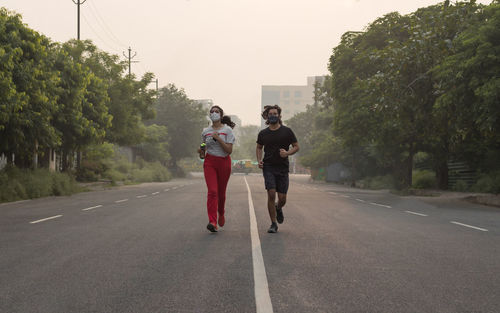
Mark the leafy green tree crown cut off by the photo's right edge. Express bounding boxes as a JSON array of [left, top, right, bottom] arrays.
[[435, 1, 500, 172]]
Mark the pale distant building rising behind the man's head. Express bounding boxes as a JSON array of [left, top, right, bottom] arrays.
[[260, 76, 325, 128]]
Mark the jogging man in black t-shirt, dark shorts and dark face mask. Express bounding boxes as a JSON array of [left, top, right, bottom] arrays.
[[256, 105, 299, 233]]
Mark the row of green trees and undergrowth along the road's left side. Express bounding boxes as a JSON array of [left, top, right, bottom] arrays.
[[0, 8, 207, 201]]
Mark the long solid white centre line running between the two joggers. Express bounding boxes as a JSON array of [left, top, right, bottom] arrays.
[[243, 177, 273, 313]]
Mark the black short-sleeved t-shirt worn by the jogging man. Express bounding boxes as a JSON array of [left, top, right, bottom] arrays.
[[257, 125, 297, 169]]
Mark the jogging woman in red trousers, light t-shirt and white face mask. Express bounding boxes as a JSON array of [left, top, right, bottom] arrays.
[[198, 105, 235, 232]]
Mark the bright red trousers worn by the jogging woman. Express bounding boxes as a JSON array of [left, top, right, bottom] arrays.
[[203, 154, 231, 225]]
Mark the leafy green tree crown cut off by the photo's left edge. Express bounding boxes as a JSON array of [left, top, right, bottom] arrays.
[[0, 8, 60, 167]]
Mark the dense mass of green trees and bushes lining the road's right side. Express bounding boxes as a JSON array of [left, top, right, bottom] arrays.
[[287, 0, 500, 193]]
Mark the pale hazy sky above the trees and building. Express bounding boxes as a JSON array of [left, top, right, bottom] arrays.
[[0, 0, 491, 125]]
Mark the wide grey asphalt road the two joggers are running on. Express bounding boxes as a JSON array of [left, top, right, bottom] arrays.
[[0, 175, 500, 313]]
